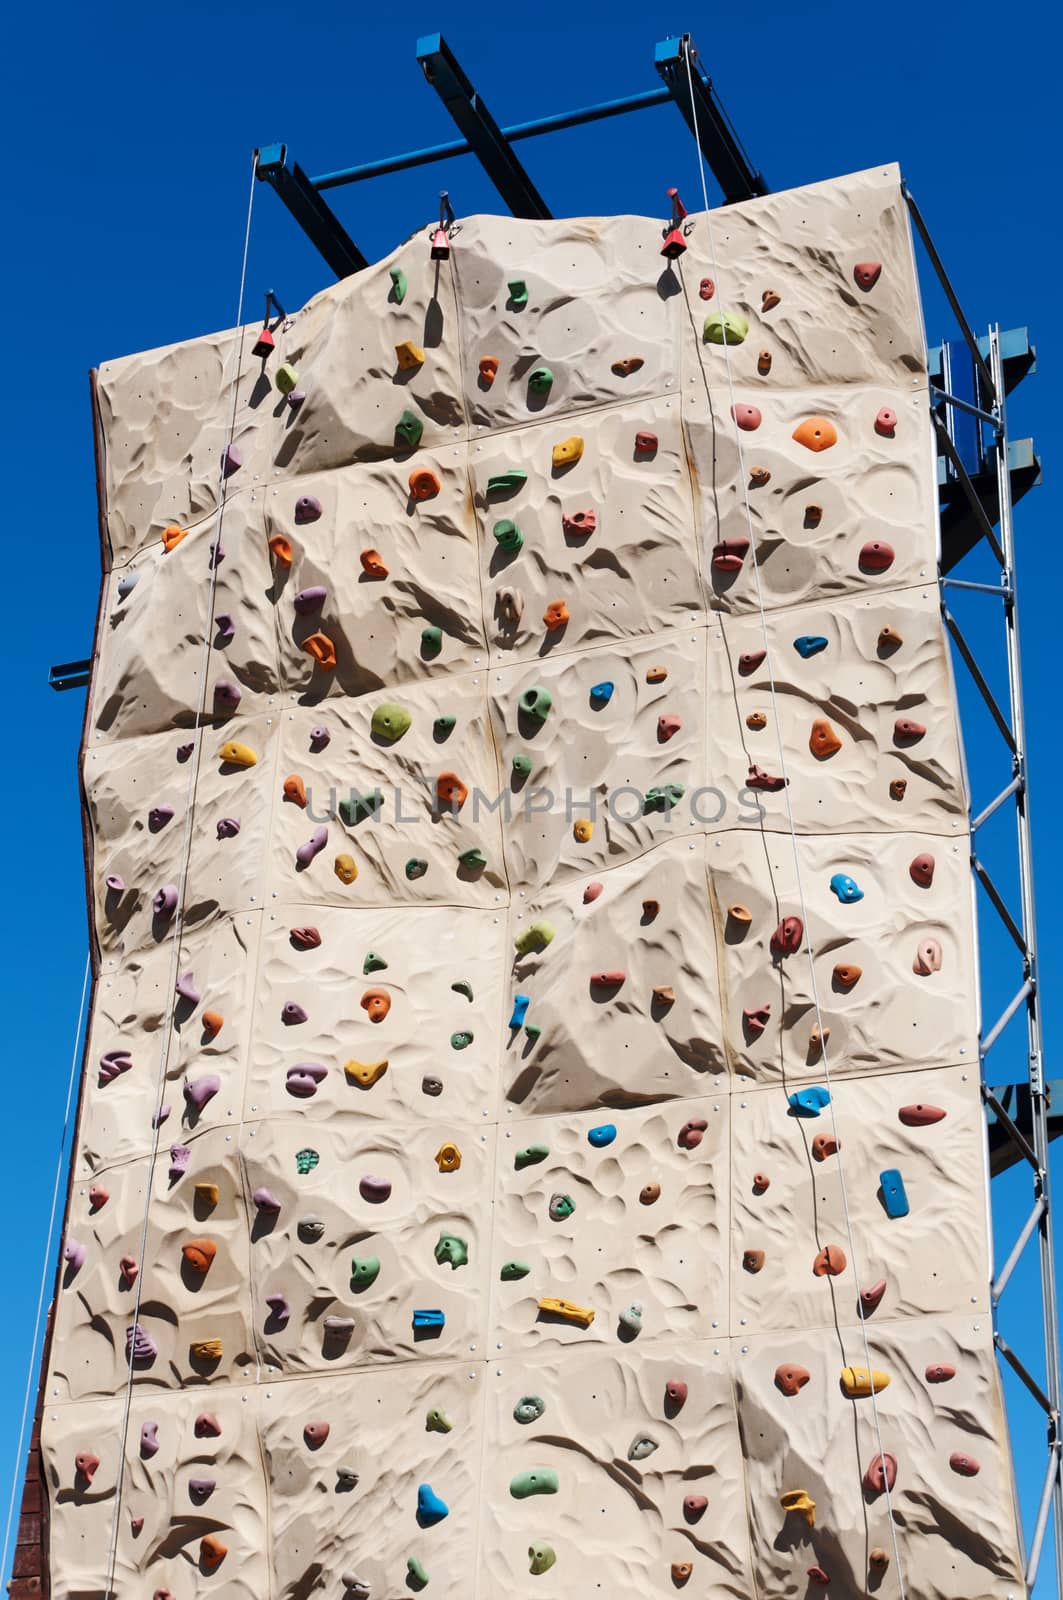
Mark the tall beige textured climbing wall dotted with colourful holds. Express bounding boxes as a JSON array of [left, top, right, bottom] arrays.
[[42, 166, 1021, 1600]]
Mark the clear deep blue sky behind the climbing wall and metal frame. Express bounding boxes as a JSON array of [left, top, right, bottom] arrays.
[[0, 0, 1063, 1595]]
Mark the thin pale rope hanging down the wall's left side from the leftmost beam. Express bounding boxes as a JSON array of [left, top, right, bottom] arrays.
[[104, 150, 258, 1600]]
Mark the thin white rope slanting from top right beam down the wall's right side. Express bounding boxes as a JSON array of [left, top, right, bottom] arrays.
[[684, 43, 905, 1600]]
